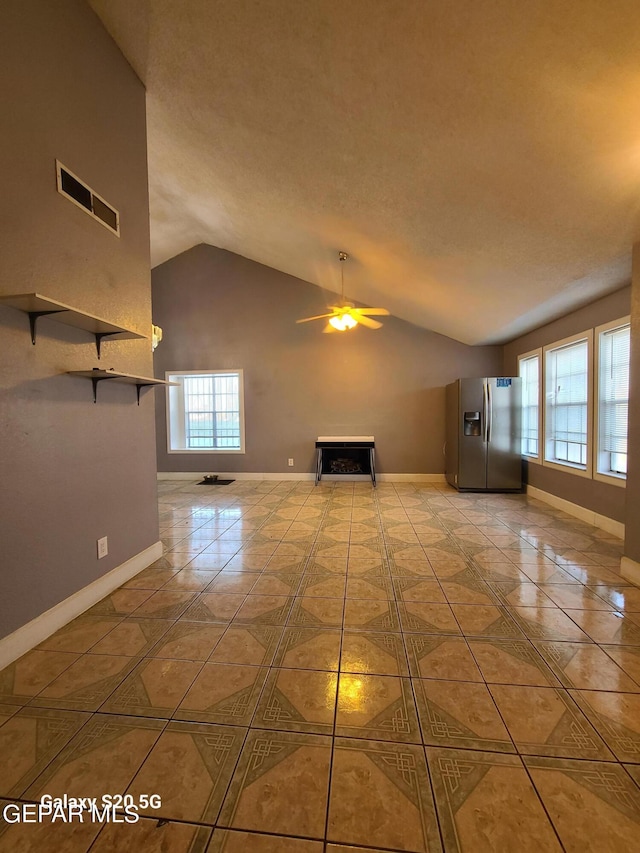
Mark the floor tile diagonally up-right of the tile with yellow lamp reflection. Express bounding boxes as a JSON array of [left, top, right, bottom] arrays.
[[404, 634, 482, 681]]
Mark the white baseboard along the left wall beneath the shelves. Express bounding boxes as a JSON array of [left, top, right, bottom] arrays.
[[0, 542, 162, 669]]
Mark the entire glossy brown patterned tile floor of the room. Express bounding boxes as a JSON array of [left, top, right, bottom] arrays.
[[0, 481, 640, 853]]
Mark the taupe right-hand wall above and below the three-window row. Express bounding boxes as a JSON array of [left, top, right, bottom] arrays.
[[504, 287, 631, 522]]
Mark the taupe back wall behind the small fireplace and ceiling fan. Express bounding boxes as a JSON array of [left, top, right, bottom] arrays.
[[152, 245, 502, 474]]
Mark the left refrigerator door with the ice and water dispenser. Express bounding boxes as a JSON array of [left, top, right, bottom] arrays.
[[457, 379, 487, 489]]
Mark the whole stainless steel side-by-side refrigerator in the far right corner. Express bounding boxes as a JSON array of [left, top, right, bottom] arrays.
[[445, 376, 522, 491]]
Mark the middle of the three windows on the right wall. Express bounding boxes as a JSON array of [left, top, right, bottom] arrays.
[[544, 331, 592, 477]]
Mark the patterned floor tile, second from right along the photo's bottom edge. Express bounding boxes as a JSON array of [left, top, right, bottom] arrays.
[[427, 747, 562, 853]]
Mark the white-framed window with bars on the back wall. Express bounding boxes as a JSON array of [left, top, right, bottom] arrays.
[[166, 370, 244, 453]]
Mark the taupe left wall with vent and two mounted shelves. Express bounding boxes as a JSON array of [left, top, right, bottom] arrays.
[[0, 0, 158, 636]]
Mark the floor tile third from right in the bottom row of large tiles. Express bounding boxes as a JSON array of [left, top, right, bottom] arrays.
[[327, 738, 442, 853]]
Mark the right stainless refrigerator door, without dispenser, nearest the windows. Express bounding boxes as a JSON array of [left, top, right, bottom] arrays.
[[486, 377, 522, 489]]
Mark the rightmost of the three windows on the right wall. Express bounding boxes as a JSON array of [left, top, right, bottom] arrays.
[[596, 317, 631, 485]]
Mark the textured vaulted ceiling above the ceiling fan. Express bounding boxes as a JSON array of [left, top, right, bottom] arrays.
[[91, 0, 640, 343]]
